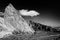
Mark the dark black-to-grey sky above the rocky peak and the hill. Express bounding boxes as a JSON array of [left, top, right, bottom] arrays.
[[0, 1, 60, 26]]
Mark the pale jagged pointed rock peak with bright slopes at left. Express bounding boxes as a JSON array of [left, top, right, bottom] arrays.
[[0, 4, 34, 38]]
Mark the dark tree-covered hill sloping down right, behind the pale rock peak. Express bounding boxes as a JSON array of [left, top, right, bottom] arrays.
[[30, 21, 60, 33]]
